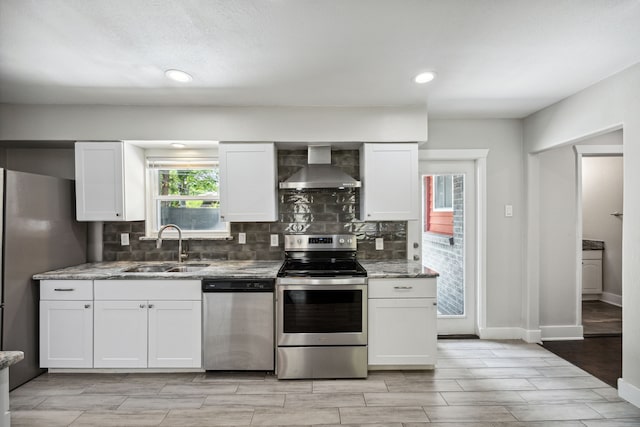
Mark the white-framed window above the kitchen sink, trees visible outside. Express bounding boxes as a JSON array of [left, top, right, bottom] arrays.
[[147, 157, 229, 238]]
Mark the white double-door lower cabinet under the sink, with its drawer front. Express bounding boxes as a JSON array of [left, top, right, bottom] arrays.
[[93, 280, 202, 368]]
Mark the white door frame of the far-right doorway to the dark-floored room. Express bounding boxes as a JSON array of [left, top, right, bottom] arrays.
[[573, 145, 623, 328]]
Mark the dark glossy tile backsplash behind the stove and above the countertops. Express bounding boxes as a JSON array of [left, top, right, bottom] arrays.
[[103, 150, 407, 261]]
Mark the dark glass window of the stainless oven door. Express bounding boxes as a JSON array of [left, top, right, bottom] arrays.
[[283, 289, 362, 333]]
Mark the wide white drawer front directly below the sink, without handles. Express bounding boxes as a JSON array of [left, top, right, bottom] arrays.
[[95, 280, 202, 301]]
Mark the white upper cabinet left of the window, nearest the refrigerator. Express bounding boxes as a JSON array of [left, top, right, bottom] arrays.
[[75, 142, 145, 221]]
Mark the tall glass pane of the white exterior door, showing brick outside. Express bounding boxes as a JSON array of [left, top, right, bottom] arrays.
[[421, 175, 465, 316]]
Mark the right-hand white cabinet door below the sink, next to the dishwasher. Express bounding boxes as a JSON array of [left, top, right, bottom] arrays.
[[149, 301, 202, 368]]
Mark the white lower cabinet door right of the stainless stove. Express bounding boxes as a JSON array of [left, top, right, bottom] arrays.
[[369, 298, 437, 365]]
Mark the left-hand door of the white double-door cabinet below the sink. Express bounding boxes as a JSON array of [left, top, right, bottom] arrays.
[[93, 301, 147, 368]]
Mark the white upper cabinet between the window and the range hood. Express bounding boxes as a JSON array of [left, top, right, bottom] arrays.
[[219, 142, 278, 222]]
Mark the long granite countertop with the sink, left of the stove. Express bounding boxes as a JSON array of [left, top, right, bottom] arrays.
[[33, 260, 282, 280]]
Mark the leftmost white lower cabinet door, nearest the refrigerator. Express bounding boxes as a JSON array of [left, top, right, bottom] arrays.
[[40, 301, 93, 368]]
